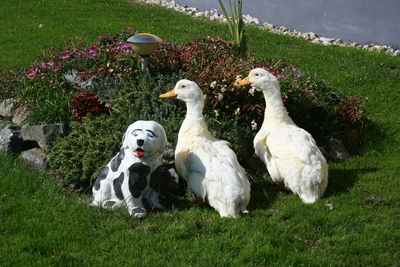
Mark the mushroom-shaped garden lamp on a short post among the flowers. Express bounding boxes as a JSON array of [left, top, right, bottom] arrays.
[[128, 33, 161, 73]]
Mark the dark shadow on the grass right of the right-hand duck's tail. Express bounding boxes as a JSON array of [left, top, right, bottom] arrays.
[[324, 168, 378, 197]]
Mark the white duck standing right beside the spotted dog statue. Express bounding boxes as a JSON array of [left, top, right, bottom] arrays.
[[160, 80, 250, 218]]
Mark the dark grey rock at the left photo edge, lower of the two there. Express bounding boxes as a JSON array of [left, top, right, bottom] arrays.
[[0, 125, 23, 154]]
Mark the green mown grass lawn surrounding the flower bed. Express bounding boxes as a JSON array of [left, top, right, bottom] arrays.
[[0, 0, 400, 266]]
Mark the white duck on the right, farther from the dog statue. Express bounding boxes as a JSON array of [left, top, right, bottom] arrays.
[[237, 68, 328, 203]]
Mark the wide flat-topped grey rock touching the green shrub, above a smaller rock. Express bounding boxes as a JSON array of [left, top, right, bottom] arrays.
[[21, 123, 66, 151]]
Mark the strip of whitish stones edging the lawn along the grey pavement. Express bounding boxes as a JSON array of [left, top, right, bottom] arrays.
[[141, 0, 400, 56]]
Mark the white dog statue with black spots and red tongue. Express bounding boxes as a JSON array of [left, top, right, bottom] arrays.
[[90, 121, 167, 218]]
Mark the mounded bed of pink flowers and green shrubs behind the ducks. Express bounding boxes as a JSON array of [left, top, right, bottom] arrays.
[[0, 28, 366, 188]]
